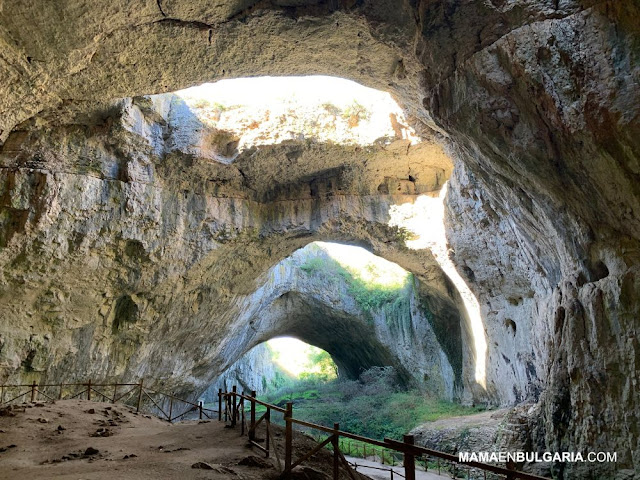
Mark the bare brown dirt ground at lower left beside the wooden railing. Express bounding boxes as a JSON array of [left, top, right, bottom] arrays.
[[0, 400, 368, 480]]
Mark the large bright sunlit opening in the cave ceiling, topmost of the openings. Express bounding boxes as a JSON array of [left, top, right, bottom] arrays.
[[172, 76, 419, 162]]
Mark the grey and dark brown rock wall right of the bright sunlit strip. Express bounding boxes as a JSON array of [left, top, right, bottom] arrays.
[[430, 2, 640, 478]]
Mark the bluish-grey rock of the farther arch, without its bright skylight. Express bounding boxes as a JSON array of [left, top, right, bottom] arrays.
[[218, 245, 463, 399]]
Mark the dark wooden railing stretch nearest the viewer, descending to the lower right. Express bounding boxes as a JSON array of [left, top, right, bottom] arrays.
[[218, 387, 548, 480]]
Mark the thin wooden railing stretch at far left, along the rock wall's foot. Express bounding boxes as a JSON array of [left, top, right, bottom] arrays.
[[0, 380, 217, 422]]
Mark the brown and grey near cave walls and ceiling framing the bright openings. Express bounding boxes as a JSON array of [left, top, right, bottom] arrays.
[[0, 0, 640, 478]]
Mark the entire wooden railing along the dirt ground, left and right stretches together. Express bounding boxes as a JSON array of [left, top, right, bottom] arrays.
[[0, 380, 548, 480]]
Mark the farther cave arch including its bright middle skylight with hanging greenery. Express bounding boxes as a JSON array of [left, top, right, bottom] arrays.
[[215, 242, 462, 399]]
